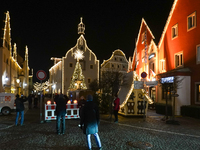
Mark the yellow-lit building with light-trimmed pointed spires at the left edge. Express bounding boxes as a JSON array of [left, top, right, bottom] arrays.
[[0, 12, 32, 96]]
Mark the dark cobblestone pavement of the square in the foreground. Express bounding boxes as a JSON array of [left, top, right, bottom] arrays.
[[0, 102, 200, 150]]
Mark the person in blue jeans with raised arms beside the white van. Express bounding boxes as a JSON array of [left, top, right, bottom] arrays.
[[15, 94, 27, 126]]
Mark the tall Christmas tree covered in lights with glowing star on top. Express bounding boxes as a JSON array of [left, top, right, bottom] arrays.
[[69, 50, 87, 91]]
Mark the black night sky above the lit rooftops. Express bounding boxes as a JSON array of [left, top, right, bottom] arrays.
[[0, 0, 174, 81]]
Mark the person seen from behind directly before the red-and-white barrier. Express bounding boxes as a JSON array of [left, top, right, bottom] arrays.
[[55, 94, 66, 135]]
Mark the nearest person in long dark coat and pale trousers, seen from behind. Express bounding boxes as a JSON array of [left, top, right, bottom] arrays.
[[81, 95, 101, 149]]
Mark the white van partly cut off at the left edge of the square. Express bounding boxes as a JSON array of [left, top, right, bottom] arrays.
[[0, 93, 16, 115]]
